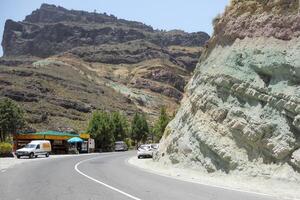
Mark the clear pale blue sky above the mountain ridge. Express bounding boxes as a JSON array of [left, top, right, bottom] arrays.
[[0, 0, 230, 56]]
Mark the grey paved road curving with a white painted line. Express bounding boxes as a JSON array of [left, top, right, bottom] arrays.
[[0, 152, 271, 200]]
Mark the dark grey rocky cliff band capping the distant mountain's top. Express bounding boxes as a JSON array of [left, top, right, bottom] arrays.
[[2, 4, 209, 58]]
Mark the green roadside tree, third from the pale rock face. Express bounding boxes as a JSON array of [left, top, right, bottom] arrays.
[[111, 112, 128, 141]]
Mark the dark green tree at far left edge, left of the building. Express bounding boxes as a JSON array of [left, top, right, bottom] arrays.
[[0, 98, 25, 142]]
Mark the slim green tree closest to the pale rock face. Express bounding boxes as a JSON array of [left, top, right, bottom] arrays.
[[153, 107, 170, 142]]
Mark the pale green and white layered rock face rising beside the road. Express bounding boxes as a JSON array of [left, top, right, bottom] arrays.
[[156, 0, 300, 181]]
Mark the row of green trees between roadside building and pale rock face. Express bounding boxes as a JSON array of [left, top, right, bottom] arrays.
[[87, 107, 170, 151]]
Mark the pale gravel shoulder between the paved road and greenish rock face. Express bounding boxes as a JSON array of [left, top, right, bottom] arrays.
[[128, 157, 300, 200]]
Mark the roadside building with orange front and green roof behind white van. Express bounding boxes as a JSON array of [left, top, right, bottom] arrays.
[[13, 131, 90, 154]]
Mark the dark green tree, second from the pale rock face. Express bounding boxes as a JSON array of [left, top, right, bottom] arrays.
[[131, 113, 149, 145]]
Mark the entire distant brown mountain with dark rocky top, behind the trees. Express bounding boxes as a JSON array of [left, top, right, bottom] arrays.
[[0, 4, 209, 130]]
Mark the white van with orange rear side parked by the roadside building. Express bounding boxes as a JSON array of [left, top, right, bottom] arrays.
[[16, 140, 51, 158]]
